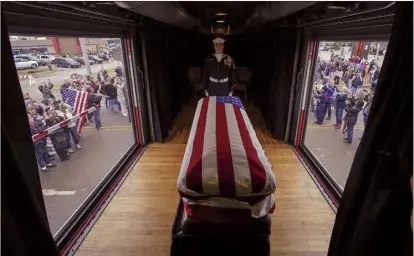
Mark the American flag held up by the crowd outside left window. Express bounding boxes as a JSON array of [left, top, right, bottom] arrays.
[[62, 88, 89, 134]]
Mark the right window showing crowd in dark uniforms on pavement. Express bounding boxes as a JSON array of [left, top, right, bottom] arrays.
[[304, 41, 388, 190]]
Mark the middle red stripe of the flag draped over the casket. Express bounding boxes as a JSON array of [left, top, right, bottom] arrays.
[[216, 103, 236, 197]]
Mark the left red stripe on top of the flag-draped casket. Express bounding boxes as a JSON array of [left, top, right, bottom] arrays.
[[186, 97, 209, 193]]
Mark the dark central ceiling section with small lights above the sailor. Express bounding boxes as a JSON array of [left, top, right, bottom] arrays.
[[180, 1, 263, 29]]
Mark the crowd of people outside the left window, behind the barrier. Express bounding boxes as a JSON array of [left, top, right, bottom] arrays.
[[23, 65, 131, 171]]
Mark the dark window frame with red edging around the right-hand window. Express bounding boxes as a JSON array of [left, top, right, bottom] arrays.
[[289, 8, 395, 211]]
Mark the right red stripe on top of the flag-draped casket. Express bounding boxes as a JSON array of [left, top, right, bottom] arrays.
[[233, 105, 267, 193]]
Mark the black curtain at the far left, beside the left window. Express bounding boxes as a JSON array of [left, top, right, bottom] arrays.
[[1, 13, 59, 256]]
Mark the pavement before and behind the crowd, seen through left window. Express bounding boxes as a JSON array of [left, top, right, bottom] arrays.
[[20, 61, 135, 234]]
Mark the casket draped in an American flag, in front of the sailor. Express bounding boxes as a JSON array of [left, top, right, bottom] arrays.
[[177, 96, 276, 220]]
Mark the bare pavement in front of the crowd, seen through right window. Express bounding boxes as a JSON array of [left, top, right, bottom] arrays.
[[304, 105, 364, 189]]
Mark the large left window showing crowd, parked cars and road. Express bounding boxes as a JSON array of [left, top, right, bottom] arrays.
[[11, 35, 136, 234]]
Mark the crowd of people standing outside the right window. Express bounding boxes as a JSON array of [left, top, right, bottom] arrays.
[[311, 55, 380, 143]]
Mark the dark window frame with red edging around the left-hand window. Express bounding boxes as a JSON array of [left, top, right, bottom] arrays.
[[2, 2, 147, 252]]
